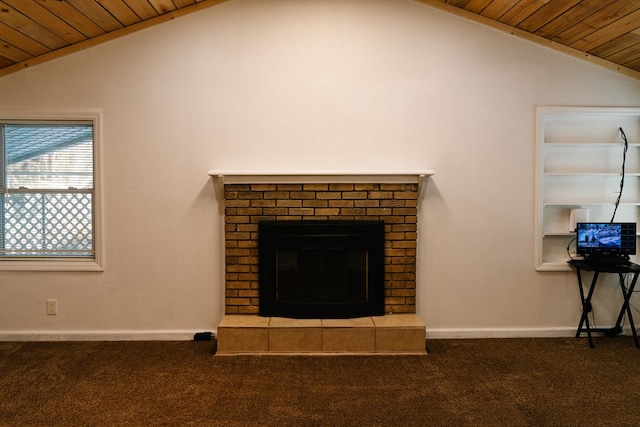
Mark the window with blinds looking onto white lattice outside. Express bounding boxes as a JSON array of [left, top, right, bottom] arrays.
[[0, 113, 101, 270]]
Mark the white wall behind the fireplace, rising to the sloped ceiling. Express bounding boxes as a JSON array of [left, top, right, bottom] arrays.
[[0, 0, 640, 339]]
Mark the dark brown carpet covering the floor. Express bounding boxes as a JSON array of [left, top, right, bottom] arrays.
[[0, 337, 640, 426]]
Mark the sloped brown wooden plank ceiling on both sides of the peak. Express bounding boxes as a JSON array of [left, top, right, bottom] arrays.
[[0, 0, 640, 79]]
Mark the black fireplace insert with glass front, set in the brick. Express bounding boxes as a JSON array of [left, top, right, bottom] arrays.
[[259, 220, 384, 318]]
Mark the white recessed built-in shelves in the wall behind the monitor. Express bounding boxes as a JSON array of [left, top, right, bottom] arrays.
[[535, 107, 640, 271]]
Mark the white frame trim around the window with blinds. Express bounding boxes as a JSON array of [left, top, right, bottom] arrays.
[[0, 110, 104, 271]]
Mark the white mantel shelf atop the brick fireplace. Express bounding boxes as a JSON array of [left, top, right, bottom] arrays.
[[209, 170, 435, 200]]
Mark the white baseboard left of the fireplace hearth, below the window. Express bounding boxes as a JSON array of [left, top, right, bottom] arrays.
[[0, 329, 207, 341]]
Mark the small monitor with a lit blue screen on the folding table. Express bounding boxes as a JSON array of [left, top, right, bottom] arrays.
[[576, 222, 636, 256]]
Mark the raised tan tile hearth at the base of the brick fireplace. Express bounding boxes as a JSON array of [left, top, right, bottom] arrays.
[[216, 314, 426, 355]]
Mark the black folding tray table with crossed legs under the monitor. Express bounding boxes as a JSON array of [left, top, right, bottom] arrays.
[[569, 260, 640, 348]]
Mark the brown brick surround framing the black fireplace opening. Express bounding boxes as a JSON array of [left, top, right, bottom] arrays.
[[224, 183, 418, 314]]
